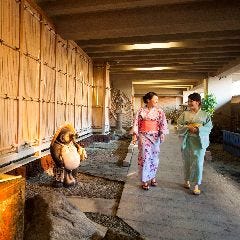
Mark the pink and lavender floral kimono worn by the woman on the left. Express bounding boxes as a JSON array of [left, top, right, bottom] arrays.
[[133, 107, 168, 182]]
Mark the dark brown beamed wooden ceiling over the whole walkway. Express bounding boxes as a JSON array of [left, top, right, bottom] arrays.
[[36, 0, 240, 93]]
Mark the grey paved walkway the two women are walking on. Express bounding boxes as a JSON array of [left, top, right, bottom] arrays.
[[117, 126, 240, 240]]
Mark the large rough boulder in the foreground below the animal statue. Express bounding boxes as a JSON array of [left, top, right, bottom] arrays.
[[24, 190, 103, 240]]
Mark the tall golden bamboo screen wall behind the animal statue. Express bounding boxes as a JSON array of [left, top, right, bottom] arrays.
[[0, 0, 93, 158]]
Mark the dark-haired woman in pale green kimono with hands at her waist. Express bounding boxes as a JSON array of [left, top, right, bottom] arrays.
[[177, 93, 212, 195]]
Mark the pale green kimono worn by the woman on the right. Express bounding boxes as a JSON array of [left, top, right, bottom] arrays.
[[177, 109, 212, 185]]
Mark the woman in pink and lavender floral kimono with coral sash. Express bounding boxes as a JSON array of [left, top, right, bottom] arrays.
[[132, 92, 168, 190]]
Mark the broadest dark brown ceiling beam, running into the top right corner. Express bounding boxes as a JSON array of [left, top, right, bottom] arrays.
[[54, 1, 240, 40]]
